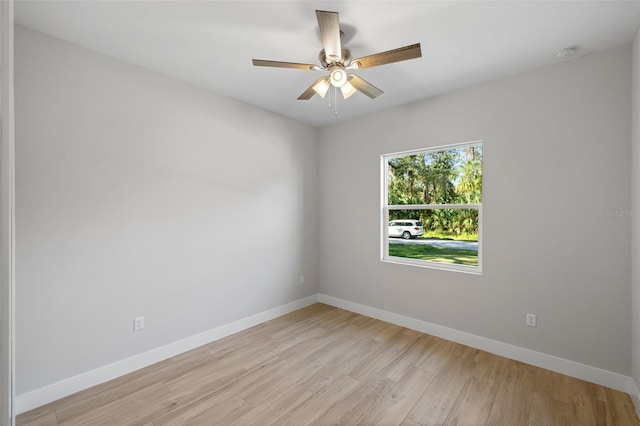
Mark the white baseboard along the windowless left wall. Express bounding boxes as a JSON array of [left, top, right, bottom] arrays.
[[15, 295, 318, 414]]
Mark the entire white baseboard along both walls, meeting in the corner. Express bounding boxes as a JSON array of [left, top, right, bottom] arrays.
[[15, 294, 640, 416]]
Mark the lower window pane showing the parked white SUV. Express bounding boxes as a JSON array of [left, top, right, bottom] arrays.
[[388, 209, 478, 266]]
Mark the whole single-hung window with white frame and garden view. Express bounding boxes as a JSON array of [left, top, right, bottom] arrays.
[[381, 141, 482, 274]]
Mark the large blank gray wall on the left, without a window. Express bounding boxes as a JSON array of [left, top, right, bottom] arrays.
[[15, 27, 317, 394]]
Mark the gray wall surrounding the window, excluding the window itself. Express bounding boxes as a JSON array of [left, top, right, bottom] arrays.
[[319, 48, 631, 375]]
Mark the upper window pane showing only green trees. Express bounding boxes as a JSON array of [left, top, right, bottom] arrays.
[[387, 144, 482, 205]]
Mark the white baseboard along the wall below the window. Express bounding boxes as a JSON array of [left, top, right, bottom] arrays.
[[318, 294, 640, 394]]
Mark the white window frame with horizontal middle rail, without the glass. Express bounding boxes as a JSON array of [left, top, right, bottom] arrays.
[[380, 140, 484, 275]]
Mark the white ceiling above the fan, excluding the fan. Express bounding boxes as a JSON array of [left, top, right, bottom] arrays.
[[15, 0, 640, 126]]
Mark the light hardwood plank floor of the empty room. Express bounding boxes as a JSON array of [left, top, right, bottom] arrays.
[[17, 304, 640, 426]]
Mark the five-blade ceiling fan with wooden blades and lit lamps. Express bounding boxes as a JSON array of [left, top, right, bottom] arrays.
[[253, 10, 422, 100]]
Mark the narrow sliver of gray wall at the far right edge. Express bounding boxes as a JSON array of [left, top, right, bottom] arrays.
[[631, 30, 640, 400]]
